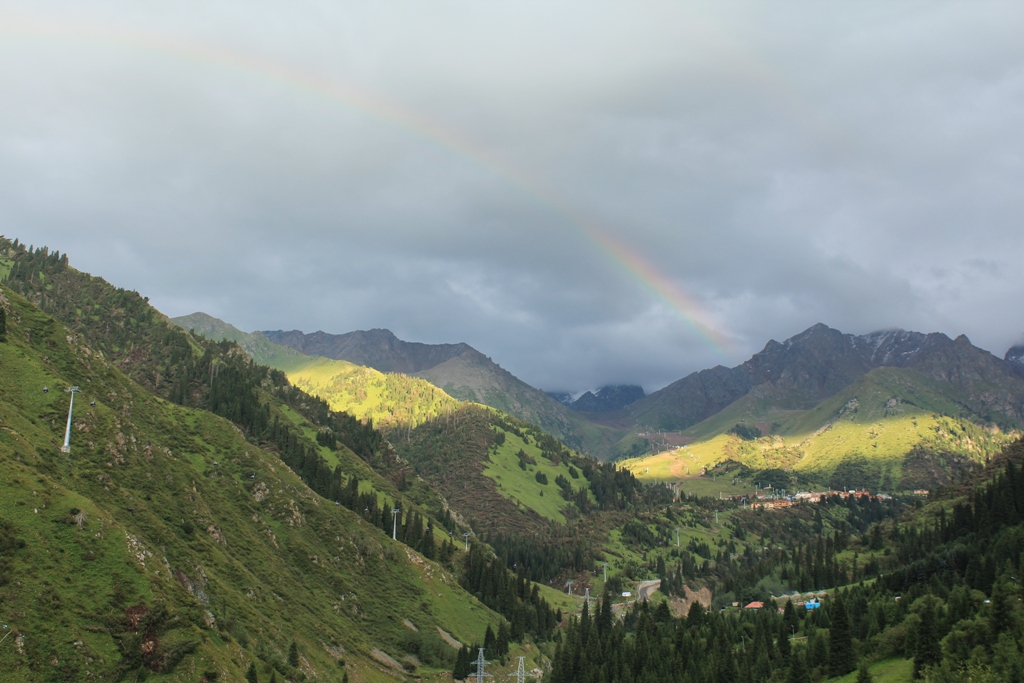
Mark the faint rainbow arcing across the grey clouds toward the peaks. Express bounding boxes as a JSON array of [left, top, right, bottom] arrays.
[[0, 16, 731, 354]]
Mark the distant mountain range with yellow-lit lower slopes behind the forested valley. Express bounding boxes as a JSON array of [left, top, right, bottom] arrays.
[[175, 313, 1024, 486]]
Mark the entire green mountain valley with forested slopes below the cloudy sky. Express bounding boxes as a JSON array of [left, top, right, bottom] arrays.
[[0, 240, 1024, 683]]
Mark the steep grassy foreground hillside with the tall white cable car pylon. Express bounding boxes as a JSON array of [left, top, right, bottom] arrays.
[[0, 289, 499, 681]]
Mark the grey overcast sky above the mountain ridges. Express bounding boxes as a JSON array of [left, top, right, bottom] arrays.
[[0, 0, 1024, 391]]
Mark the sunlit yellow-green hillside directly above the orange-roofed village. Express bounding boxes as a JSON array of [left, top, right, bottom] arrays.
[[622, 368, 1018, 489]]
